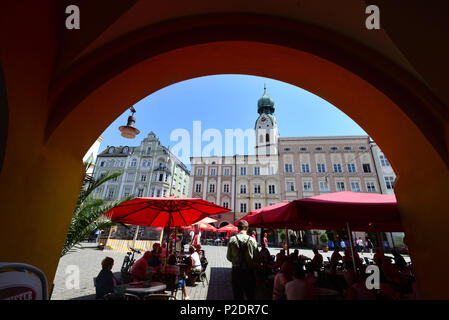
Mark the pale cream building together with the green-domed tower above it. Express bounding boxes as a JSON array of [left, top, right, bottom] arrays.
[[189, 88, 281, 227]]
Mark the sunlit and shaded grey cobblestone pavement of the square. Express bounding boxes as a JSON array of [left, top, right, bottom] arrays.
[[51, 243, 410, 300]]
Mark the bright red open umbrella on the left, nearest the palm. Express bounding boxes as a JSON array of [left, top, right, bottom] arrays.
[[105, 197, 230, 227]]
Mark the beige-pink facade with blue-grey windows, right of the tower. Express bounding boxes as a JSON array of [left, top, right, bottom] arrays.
[[279, 136, 381, 201]]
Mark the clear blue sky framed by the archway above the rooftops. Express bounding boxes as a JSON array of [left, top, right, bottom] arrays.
[[100, 75, 366, 162]]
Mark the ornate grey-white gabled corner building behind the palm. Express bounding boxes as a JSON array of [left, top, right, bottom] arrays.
[[94, 132, 190, 201]]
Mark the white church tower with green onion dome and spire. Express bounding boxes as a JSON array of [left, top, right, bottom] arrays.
[[254, 85, 279, 155]]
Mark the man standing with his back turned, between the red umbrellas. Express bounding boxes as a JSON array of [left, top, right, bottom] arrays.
[[226, 220, 259, 300]]
